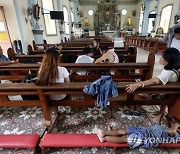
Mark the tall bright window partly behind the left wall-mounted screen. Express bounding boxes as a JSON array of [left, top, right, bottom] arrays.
[[42, 0, 57, 35]]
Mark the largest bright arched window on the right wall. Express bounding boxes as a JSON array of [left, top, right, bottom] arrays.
[[159, 5, 172, 33]]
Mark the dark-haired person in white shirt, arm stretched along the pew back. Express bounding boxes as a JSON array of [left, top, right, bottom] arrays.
[[126, 48, 180, 115]]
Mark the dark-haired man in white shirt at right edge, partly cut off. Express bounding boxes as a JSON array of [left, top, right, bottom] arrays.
[[170, 27, 180, 52]]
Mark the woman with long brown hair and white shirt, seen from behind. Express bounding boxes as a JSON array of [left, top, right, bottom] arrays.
[[35, 47, 70, 100]]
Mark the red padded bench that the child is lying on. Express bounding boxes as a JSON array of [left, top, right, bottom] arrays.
[[40, 134, 180, 148]]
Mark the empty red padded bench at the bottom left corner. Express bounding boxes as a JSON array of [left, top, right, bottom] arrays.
[[0, 134, 40, 149]]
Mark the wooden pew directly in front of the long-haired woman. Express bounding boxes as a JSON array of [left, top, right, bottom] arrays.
[[0, 50, 155, 81]]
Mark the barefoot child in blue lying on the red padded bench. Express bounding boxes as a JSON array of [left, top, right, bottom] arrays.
[[95, 123, 180, 148]]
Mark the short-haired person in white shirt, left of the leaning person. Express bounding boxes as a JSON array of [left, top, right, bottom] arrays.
[[75, 47, 94, 75]]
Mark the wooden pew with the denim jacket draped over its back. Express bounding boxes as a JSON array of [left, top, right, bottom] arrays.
[[0, 82, 180, 121]]
